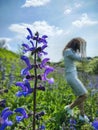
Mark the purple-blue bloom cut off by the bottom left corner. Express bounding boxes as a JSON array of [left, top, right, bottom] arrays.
[[0, 107, 13, 130]]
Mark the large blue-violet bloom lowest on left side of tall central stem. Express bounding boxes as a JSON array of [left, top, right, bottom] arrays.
[[16, 80, 33, 97]]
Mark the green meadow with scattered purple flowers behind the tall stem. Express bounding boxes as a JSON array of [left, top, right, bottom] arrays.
[[0, 49, 98, 130]]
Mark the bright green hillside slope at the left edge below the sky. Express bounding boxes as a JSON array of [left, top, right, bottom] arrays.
[[0, 48, 19, 60]]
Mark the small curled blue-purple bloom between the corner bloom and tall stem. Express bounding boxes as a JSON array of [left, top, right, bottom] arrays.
[[15, 108, 28, 122]]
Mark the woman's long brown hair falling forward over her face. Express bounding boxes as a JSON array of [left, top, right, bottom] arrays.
[[63, 37, 86, 57]]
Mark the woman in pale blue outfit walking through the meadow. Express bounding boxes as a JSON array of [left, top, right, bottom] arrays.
[[63, 38, 89, 122]]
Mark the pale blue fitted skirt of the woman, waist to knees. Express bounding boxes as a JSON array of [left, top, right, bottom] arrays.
[[66, 71, 88, 96]]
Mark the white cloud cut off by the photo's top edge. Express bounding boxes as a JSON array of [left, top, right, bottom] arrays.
[[22, 0, 50, 7]]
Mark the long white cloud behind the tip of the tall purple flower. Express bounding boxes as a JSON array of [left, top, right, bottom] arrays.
[[9, 21, 64, 36]]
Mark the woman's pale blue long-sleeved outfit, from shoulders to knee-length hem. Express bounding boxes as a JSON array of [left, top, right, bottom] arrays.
[[64, 48, 88, 96]]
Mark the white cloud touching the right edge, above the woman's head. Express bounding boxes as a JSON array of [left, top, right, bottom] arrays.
[[72, 13, 98, 28]]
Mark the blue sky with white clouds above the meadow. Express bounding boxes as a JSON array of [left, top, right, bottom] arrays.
[[0, 0, 98, 62]]
